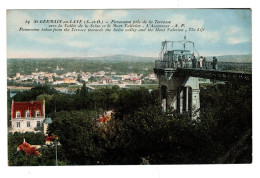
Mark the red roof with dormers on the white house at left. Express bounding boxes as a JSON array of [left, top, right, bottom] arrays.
[[12, 101, 43, 119]]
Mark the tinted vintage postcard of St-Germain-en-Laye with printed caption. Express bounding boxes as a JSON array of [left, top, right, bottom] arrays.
[[7, 9, 253, 166]]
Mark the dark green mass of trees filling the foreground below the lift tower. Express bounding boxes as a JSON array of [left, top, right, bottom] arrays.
[[9, 83, 252, 165]]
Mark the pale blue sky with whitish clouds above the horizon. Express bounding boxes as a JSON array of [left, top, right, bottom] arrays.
[[7, 9, 252, 58]]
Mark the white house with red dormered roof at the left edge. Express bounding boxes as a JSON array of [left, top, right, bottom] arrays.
[[11, 100, 45, 132]]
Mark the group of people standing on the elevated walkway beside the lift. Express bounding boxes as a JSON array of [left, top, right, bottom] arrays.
[[178, 56, 217, 70]]
